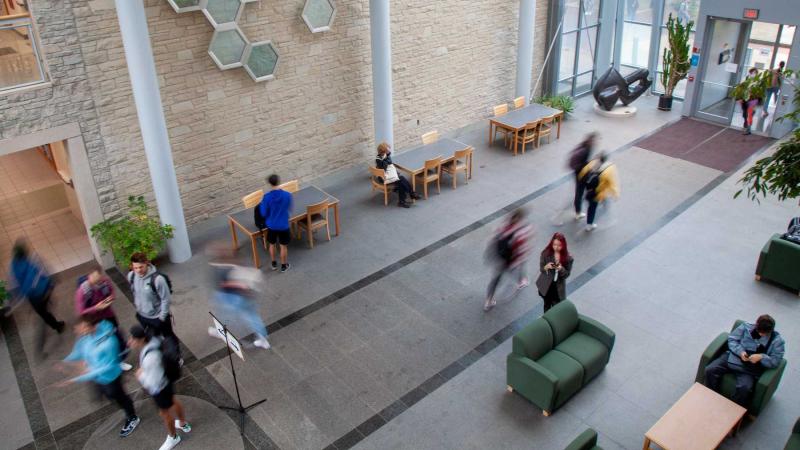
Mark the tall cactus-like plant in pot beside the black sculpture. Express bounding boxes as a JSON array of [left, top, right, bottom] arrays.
[[658, 14, 694, 111]]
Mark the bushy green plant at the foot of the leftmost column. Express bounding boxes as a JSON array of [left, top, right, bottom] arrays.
[[92, 196, 173, 267]]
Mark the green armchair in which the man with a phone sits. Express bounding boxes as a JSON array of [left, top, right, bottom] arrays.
[[694, 320, 786, 416]]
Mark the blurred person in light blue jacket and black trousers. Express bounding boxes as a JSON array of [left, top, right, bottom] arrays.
[[61, 315, 139, 437]]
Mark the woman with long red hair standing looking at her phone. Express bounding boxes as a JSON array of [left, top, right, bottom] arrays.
[[536, 233, 573, 312]]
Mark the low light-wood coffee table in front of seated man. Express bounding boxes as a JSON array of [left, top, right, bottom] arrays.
[[642, 383, 747, 450]]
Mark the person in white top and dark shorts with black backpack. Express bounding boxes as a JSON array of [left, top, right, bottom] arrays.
[[128, 325, 192, 450]]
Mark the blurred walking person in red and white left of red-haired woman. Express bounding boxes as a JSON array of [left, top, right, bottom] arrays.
[[483, 208, 532, 311]]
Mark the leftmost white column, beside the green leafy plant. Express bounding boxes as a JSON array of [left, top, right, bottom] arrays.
[[115, 0, 192, 263]]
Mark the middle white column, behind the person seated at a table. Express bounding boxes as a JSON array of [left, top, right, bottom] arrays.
[[368, 0, 394, 146]]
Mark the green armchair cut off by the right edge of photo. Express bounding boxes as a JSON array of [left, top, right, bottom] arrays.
[[756, 233, 800, 291]]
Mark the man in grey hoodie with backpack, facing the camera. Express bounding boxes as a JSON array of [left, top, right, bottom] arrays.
[[128, 253, 178, 341]]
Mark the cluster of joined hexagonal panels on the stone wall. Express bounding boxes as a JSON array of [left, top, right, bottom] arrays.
[[167, 0, 278, 81]]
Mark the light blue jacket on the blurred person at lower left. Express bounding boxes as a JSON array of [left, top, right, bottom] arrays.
[[64, 320, 122, 384]]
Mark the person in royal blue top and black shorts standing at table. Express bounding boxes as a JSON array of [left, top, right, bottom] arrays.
[[259, 174, 292, 272]]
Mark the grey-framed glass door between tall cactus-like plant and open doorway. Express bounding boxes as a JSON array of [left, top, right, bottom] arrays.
[[696, 18, 750, 125]]
